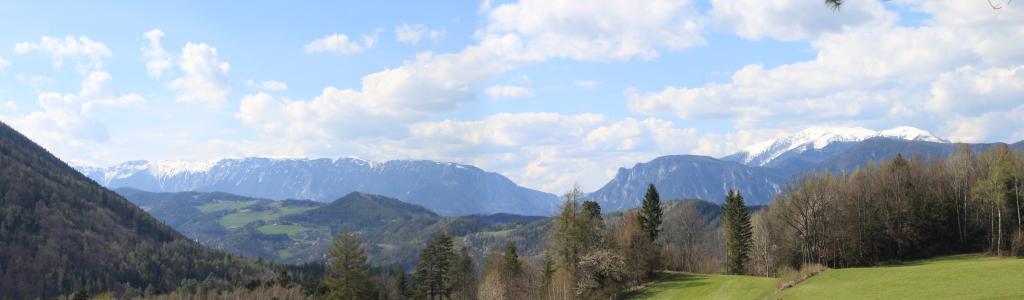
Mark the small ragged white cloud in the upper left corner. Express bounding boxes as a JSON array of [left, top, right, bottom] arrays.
[[14, 36, 114, 74]]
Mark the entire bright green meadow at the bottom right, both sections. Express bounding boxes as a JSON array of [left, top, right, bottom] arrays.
[[628, 255, 1024, 300]]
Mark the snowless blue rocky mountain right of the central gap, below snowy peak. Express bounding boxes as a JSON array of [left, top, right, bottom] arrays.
[[588, 156, 785, 212]]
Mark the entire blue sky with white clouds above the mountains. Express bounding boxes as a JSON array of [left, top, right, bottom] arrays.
[[0, 0, 1024, 194]]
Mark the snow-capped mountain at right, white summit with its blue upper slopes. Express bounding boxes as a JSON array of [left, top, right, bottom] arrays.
[[721, 126, 949, 167]]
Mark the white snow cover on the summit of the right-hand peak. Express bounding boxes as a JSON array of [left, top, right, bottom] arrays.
[[723, 126, 949, 166]]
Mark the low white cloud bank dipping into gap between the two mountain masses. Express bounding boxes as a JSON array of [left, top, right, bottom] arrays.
[[403, 113, 699, 192]]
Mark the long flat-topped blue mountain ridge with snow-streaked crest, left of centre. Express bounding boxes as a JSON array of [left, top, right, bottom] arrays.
[[75, 158, 558, 215]]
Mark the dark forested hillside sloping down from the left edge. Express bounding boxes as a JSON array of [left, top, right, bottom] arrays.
[[0, 124, 272, 299]]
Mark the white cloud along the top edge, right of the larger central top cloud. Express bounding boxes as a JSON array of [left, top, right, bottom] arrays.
[[708, 0, 898, 41]]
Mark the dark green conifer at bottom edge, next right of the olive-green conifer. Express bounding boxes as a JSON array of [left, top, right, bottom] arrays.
[[413, 229, 456, 299]]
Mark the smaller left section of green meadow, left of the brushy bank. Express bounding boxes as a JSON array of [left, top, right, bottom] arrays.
[[628, 272, 778, 300]]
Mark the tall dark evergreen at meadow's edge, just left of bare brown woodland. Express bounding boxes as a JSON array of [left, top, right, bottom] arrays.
[[722, 189, 754, 274]]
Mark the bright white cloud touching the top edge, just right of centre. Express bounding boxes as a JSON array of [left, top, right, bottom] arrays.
[[481, 0, 706, 61]]
